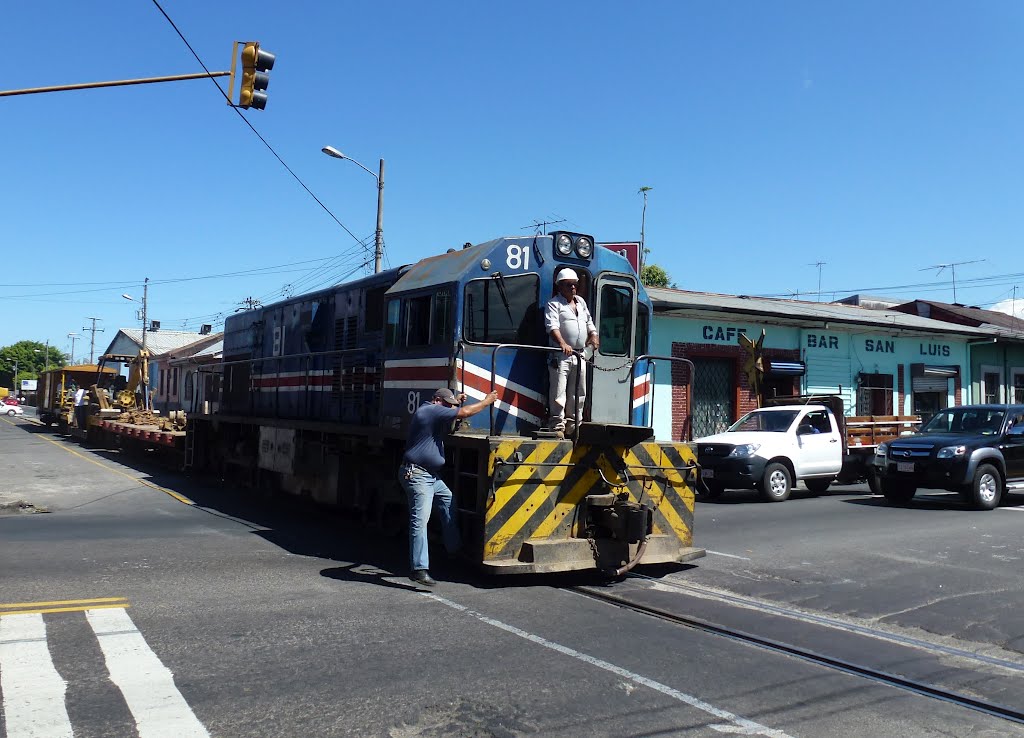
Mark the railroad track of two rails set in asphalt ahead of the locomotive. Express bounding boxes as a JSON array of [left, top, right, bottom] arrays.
[[569, 575, 1024, 725]]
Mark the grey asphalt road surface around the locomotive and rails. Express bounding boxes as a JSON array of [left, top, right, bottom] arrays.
[[0, 419, 1024, 738]]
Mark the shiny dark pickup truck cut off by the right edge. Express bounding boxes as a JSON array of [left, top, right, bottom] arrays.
[[873, 404, 1024, 510]]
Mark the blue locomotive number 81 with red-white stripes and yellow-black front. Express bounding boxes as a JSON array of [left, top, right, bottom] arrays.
[[185, 231, 703, 573]]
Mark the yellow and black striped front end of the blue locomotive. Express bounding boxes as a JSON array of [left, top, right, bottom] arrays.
[[482, 438, 705, 573]]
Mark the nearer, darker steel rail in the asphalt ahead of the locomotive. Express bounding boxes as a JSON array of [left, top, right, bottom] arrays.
[[568, 587, 1024, 725]]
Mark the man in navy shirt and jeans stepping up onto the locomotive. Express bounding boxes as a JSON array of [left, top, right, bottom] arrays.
[[398, 387, 498, 587]]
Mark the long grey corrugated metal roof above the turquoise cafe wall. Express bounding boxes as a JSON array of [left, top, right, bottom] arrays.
[[647, 287, 999, 338]]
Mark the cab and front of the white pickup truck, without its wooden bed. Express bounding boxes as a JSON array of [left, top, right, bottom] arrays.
[[694, 404, 846, 503]]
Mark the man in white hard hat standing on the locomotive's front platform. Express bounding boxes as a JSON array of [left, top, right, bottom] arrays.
[[544, 267, 600, 434]]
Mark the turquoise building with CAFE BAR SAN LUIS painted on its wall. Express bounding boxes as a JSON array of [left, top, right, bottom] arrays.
[[648, 288, 1024, 439]]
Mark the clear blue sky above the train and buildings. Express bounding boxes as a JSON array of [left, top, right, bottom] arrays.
[[0, 0, 1024, 355]]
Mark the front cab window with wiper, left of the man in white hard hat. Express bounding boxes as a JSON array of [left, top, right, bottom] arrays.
[[463, 274, 543, 345]]
